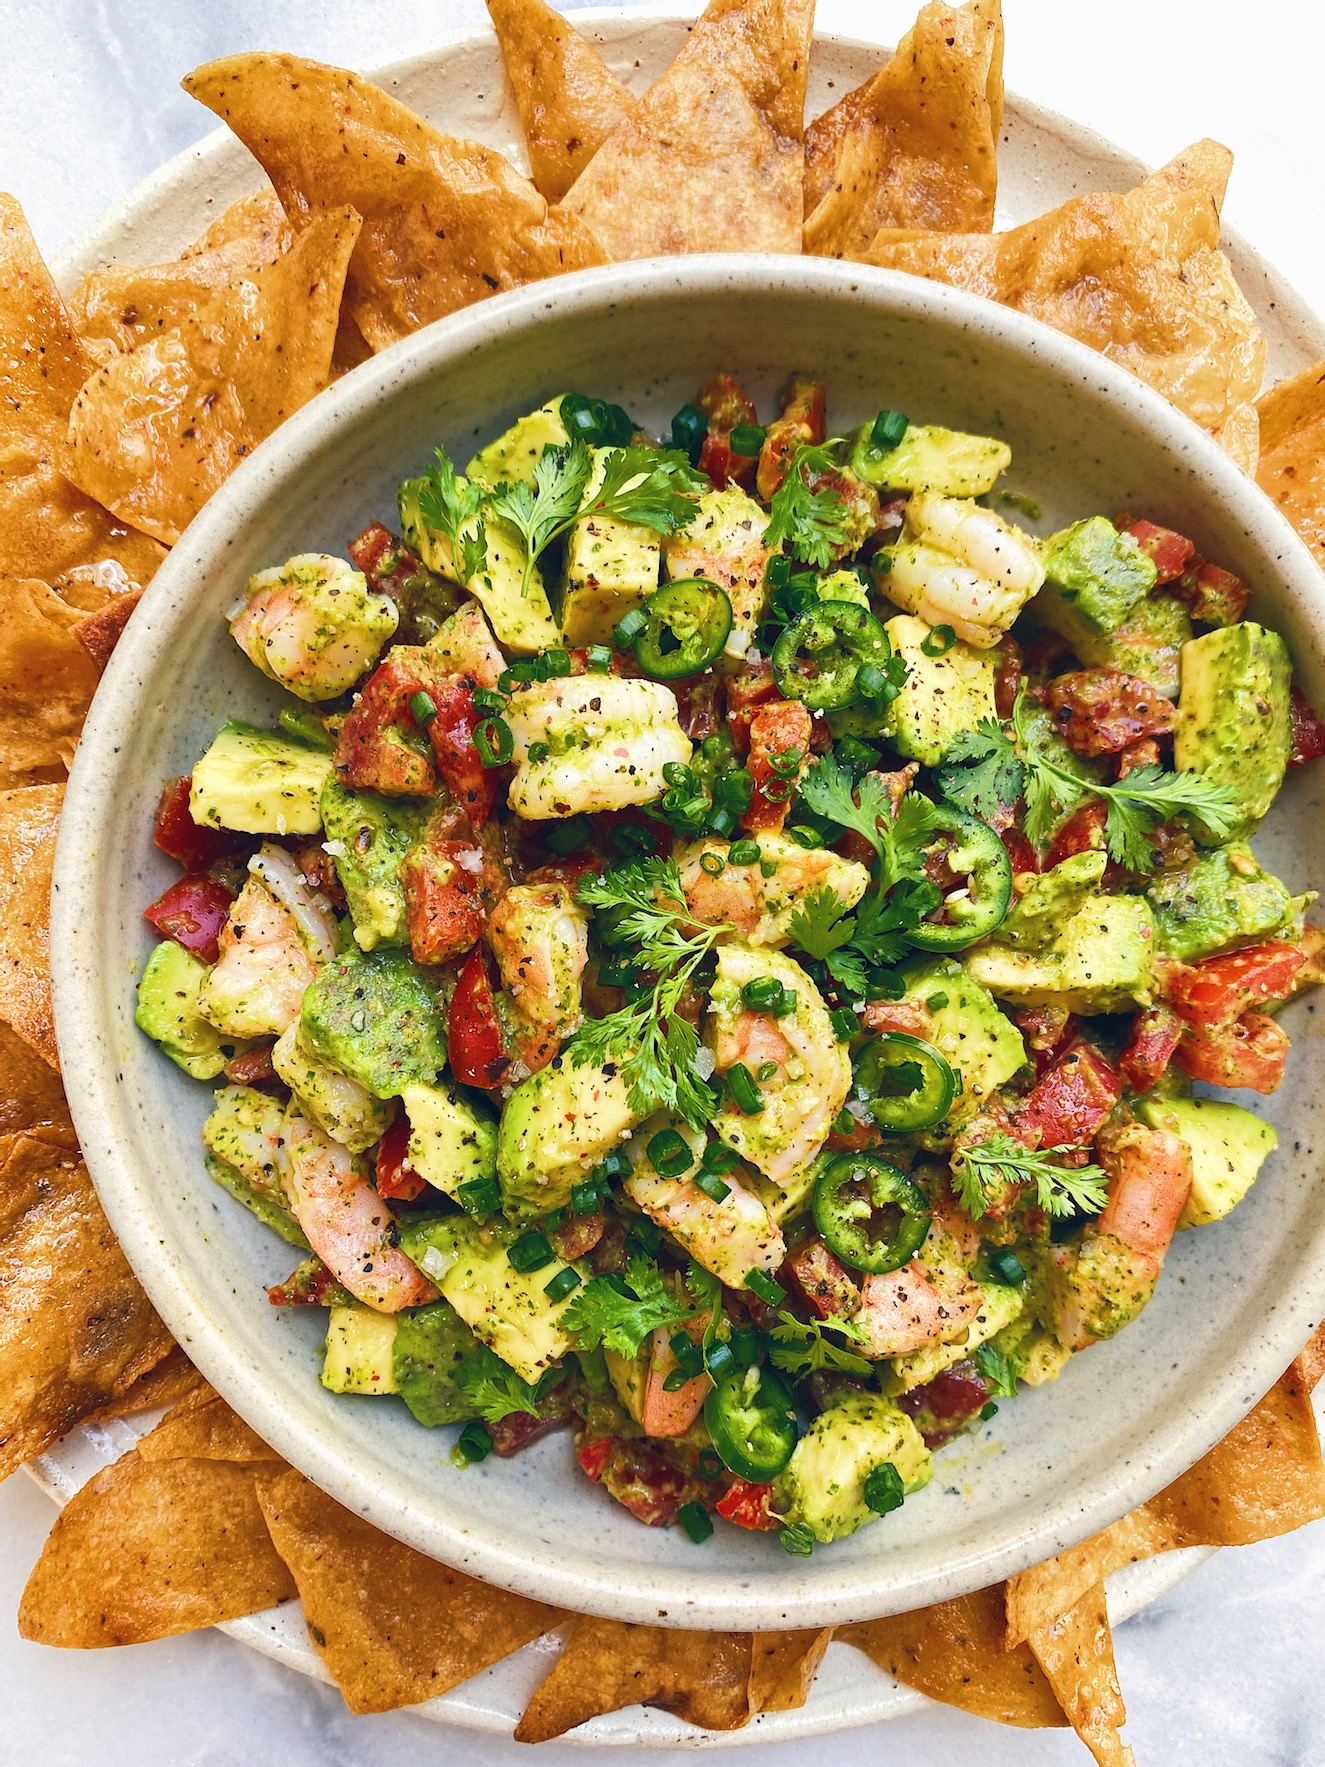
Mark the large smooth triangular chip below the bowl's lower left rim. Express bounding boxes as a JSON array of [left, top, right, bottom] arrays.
[[261, 1472, 564, 1712]]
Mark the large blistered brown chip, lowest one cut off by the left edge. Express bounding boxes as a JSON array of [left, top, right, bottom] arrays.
[[0, 1122, 171, 1477]]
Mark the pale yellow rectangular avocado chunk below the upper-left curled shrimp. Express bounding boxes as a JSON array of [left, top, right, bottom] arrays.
[[189, 723, 332, 834]]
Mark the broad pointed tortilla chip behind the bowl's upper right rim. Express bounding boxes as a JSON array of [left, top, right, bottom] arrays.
[[862, 141, 1265, 459]]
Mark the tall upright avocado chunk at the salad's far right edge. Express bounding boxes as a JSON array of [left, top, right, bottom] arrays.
[[1173, 620, 1293, 846]]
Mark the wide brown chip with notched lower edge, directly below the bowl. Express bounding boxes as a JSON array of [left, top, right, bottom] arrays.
[[516, 1617, 753, 1742]]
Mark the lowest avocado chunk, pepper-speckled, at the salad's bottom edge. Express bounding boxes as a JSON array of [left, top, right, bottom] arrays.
[[776, 1392, 933, 1543]]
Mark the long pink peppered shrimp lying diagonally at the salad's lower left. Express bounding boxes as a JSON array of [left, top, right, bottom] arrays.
[[281, 1110, 436, 1313]]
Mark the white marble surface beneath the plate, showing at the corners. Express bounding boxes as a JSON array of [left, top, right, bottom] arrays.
[[0, 0, 1325, 1767]]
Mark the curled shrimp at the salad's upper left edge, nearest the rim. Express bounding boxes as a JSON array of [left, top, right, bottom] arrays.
[[230, 553, 399, 700]]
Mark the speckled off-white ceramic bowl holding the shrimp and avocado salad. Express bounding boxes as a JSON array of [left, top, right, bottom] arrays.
[[51, 256, 1325, 1629]]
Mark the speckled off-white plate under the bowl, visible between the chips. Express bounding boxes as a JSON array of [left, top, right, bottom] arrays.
[[28, 14, 1325, 1744]]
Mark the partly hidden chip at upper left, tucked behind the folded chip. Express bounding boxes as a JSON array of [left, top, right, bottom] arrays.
[[69, 191, 293, 365]]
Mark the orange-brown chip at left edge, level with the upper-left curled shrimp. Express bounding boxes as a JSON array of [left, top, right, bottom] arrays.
[[0, 580, 97, 788]]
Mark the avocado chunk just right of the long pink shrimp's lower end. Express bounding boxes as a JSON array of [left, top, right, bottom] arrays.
[[401, 1215, 587, 1384]]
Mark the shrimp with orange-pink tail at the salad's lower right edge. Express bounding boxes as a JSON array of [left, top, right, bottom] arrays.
[[1051, 1124, 1193, 1350]]
